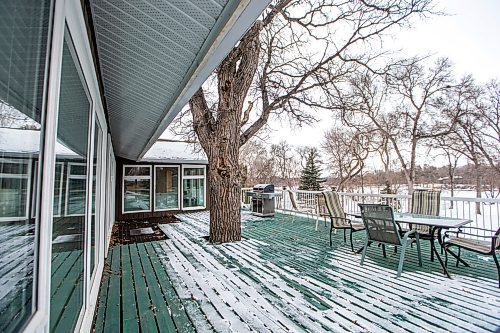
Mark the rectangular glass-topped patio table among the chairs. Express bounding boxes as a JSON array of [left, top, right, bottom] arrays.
[[347, 212, 472, 278]]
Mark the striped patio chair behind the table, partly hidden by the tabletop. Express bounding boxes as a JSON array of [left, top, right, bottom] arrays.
[[410, 190, 442, 261]]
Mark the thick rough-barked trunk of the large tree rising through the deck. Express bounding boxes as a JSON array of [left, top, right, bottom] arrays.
[[189, 22, 262, 243]]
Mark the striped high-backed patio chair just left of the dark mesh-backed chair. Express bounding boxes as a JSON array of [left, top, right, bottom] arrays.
[[323, 191, 365, 252]]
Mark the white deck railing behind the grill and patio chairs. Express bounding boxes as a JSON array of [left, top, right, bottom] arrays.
[[241, 188, 500, 234]]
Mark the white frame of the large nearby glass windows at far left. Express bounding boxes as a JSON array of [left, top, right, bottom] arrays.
[[28, 0, 112, 332]]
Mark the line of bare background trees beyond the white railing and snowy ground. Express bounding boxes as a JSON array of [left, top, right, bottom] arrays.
[[240, 58, 500, 213]]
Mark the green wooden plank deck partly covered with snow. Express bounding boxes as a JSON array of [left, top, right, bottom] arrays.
[[95, 212, 500, 332]]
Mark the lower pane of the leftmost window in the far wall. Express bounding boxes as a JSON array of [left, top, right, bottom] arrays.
[[123, 179, 151, 212]]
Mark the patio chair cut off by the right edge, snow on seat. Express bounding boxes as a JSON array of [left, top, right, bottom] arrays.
[[443, 227, 500, 288]]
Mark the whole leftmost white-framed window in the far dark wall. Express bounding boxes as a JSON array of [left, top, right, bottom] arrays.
[[122, 165, 151, 213]]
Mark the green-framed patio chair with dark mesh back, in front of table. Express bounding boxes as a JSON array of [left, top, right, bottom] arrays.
[[359, 204, 422, 277]]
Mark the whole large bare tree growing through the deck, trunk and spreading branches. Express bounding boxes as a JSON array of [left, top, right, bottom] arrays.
[[189, 0, 432, 242]]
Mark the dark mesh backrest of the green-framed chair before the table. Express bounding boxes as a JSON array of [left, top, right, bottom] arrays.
[[359, 204, 401, 245]]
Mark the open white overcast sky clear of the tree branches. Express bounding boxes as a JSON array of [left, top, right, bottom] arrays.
[[270, 0, 500, 151]]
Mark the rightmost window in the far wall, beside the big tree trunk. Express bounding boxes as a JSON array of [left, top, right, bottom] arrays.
[[182, 165, 206, 209]]
